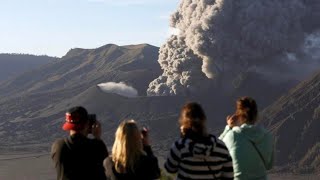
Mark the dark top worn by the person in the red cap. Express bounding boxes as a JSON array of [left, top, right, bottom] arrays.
[[51, 134, 108, 180]]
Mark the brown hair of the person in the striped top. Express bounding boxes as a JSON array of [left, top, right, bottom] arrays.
[[179, 102, 207, 136]]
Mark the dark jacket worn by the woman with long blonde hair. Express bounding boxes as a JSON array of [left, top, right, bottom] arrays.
[[104, 146, 160, 180]]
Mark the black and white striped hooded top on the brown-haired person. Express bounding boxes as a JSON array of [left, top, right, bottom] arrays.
[[165, 135, 233, 180]]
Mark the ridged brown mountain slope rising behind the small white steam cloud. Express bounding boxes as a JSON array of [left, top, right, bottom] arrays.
[[0, 45, 160, 96]]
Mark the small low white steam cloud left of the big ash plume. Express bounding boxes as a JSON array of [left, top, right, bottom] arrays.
[[97, 82, 138, 98]]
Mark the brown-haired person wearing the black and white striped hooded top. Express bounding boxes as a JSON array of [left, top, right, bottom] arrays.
[[165, 103, 233, 180]]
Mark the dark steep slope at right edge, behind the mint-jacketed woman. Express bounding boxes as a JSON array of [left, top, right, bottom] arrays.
[[262, 71, 320, 172]]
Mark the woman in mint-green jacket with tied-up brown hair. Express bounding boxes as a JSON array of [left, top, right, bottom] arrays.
[[220, 97, 274, 180]]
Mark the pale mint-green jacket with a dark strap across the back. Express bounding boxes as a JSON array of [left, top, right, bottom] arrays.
[[219, 124, 274, 180]]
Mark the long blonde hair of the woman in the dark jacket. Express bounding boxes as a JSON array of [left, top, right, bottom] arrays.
[[112, 120, 144, 173]]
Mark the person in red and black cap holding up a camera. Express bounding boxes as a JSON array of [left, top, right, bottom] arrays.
[[51, 106, 108, 180]]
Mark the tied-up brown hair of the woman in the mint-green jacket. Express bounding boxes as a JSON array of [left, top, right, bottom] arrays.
[[236, 97, 258, 124]]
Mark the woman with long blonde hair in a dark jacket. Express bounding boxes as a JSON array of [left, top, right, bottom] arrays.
[[104, 120, 160, 180]]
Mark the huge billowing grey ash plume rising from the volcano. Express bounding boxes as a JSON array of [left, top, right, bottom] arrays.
[[147, 0, 320, 95]]
